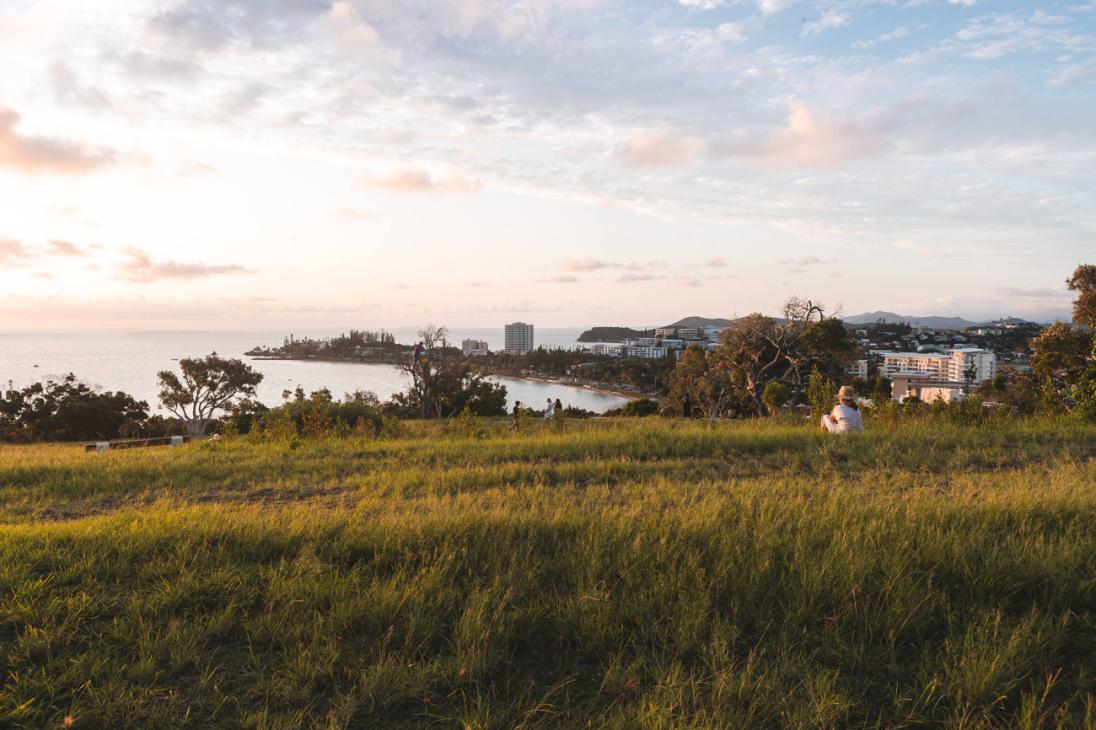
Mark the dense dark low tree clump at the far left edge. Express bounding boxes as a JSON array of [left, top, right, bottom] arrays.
[[0, 373, 149, 442]]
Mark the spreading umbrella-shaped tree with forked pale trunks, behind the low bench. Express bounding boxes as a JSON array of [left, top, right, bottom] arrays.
[[157, 353, 263, 435]]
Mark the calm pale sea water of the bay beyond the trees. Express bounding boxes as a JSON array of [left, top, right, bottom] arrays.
[[0, 328, 626, 413]]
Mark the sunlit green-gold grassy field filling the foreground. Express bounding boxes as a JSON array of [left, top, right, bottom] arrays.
[[0, 420, 1096, 728]]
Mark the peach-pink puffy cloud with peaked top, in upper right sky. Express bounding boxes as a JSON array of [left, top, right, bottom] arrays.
[[745, 102, 880, 169]]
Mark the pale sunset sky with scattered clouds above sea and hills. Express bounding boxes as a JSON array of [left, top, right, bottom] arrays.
[[0, 0, 1096, 331]]
